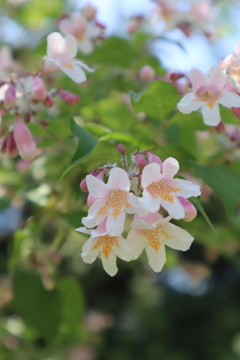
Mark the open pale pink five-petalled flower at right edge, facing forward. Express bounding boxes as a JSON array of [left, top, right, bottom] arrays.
[[177, 65, 240, 126]]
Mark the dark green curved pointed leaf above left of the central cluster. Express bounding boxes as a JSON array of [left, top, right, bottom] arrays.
[[70, 117, 98, 165]]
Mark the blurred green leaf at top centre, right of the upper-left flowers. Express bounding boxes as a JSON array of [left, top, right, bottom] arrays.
[[91, 37, 138, 68]]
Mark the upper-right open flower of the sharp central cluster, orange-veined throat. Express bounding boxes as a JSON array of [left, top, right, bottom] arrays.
[[142, 157, 201, 219]]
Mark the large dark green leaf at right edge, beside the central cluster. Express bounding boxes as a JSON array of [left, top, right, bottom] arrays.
[[191, 163, 240, 217]]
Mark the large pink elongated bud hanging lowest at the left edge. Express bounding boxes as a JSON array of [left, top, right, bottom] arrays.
[[13, 119, 36, 160]]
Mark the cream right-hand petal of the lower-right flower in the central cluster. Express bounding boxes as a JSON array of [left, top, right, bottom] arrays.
[[163, 223, 194, 251]]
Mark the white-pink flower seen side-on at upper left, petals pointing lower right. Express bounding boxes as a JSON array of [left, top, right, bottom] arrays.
[[43, 32, 93, 83]]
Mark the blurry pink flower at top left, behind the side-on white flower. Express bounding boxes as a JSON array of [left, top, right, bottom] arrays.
[[59, 12, 102, 54]]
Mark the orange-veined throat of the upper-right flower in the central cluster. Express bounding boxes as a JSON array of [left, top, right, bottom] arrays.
[[146, 180, 181, 204]]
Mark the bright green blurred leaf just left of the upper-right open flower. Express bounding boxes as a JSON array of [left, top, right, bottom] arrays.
[[130, 81, 180, 120]]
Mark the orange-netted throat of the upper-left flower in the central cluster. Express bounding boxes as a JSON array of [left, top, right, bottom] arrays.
[[98, 190, 131, 219]]
